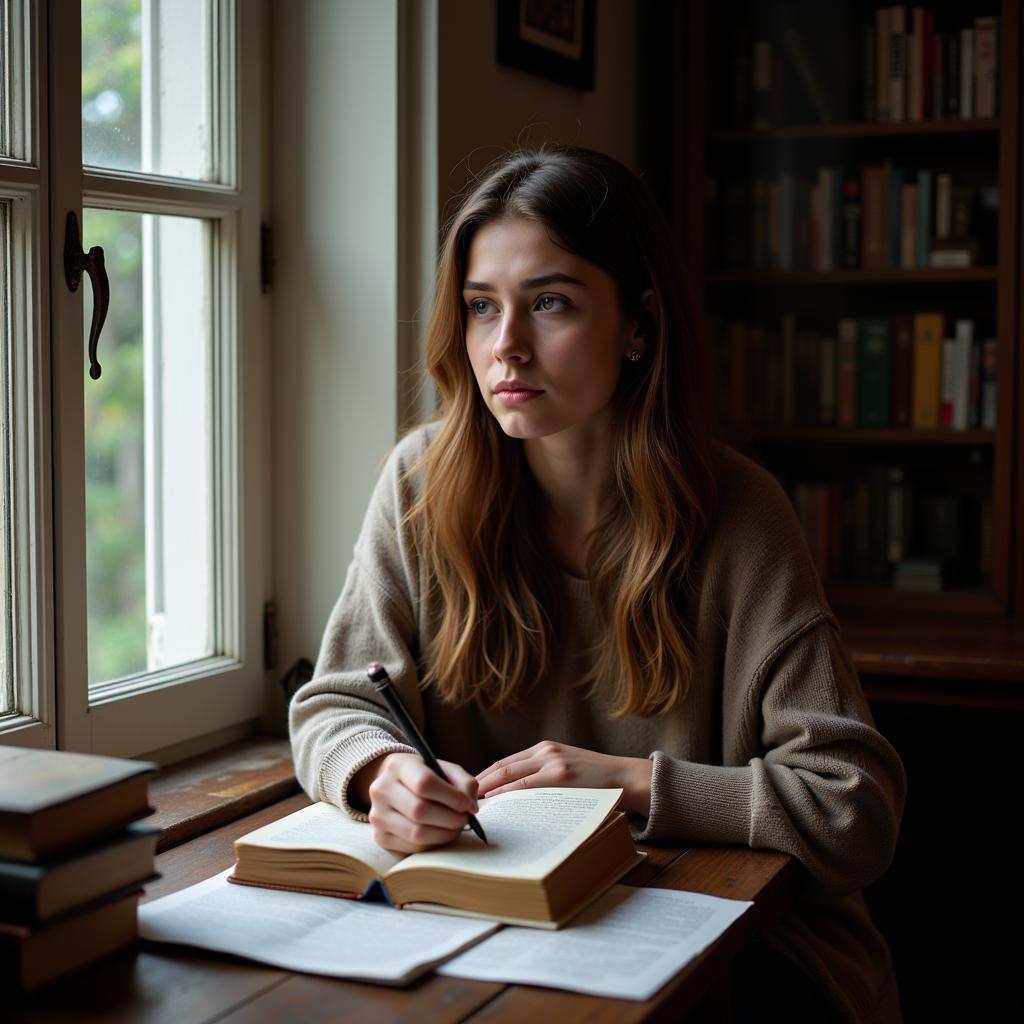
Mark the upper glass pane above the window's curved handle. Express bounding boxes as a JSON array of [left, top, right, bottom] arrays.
[[82, 0, 226, 180]]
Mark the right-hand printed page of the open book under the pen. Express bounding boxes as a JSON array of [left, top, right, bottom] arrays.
[[391, 788, 623, 879]]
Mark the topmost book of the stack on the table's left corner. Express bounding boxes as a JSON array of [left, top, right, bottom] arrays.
[[0, 746, 157, 862]]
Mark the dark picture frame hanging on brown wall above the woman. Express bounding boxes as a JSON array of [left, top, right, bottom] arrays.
[[498, 0, 596, 90]]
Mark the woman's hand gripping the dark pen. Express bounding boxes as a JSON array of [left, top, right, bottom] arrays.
[[350, 754, 478, 853]]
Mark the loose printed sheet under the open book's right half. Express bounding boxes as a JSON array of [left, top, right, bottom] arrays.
[[438, 886, 754, 999]]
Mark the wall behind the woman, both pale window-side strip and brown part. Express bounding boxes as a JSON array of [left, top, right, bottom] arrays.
[[271, 0, 638, 717]]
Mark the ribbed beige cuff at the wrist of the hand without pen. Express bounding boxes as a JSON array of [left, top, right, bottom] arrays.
[[634, 751, 752, 846]]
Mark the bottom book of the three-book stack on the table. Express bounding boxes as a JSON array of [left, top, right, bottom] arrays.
[[0, 891, 138, 992]]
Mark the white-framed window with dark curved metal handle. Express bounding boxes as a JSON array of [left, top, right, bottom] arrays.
[[0, 0, 266, 756]]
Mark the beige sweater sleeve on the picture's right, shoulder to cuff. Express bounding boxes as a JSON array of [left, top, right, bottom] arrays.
[[638, 452, 906, 901]]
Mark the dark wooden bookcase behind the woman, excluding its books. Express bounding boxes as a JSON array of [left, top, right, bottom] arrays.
[[646, 0, 1024, 638]]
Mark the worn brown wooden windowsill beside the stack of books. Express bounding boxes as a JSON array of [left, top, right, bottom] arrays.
[[145, 736, 299, 851]]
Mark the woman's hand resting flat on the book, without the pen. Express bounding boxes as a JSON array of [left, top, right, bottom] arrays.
[[476, 739, 652, 817]]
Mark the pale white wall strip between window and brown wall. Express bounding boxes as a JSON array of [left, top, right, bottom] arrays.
[[271, 0, 397, 724]]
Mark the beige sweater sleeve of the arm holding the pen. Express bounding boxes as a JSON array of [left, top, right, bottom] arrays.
[[289, 435, 432, 820]]
